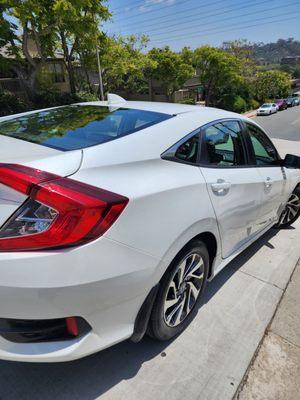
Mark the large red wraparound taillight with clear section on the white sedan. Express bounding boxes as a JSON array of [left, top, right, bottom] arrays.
[[0, 164, 128, 251]]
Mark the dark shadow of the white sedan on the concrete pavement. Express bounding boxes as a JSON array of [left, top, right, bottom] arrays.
[[0, 229, 286, 400]]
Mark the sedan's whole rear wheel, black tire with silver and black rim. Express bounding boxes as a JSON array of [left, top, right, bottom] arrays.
[[147, 240, 209, 340]]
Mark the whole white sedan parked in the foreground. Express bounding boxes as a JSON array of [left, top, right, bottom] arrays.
[[0, 95, 300, 362]]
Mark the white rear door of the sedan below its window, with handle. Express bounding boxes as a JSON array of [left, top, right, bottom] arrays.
[[201, 168, 262, 258]]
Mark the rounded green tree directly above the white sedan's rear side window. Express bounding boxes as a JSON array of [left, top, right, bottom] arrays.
[[194, 46, 244, 106]]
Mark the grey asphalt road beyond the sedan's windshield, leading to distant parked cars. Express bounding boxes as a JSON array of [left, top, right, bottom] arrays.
[[254, 106, 300, 141]]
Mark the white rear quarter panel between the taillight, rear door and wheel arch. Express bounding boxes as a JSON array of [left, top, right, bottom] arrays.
[[70, 159, 219, 280]]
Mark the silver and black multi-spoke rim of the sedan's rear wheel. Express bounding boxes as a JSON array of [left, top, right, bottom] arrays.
[[164, 253, 205, 327]]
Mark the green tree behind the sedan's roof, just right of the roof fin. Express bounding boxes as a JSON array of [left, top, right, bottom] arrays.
[[146, 47, 194, 101]]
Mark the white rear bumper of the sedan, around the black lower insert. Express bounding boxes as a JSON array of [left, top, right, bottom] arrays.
[[0, 238, 159, 362]]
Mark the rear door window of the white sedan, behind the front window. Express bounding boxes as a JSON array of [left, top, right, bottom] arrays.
[[203, 121, 246, 167]]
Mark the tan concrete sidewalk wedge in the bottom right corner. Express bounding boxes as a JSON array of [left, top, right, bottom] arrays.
[[235, 260, 300, 400]]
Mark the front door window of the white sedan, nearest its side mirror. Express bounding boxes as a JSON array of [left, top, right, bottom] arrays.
[[246, 124, 279, 166]]
